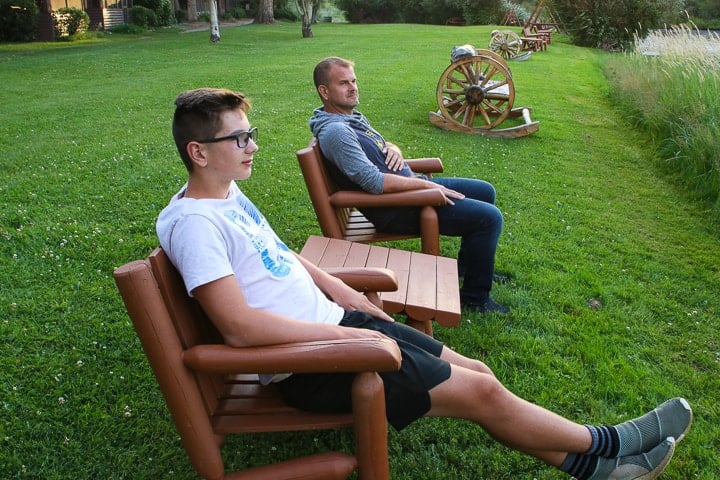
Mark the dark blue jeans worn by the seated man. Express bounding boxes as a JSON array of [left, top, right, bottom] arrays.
[[363, 177, 503, 303]]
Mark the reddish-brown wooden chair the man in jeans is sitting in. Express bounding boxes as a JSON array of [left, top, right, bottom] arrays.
[[297, 139, 445, 255]]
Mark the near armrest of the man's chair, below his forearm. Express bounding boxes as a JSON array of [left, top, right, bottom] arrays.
[[330, 188, 447, 208]]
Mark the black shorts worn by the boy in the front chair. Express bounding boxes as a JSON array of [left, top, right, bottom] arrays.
[[277, 312, 450, 430]]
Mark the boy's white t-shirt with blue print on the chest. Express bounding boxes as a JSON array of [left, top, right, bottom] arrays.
[[156, 183, 344, 325]]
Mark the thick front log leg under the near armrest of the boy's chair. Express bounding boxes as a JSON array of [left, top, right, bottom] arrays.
[[352, 372, 390, 480]]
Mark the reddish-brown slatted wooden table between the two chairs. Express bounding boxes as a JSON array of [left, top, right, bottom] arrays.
[[300, 236, 460, 335]]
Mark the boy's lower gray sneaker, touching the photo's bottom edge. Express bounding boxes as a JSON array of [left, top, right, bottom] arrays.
[[588, 437, 675, 480]]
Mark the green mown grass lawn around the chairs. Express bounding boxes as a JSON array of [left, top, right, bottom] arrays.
[[0, 23, 720, 480]]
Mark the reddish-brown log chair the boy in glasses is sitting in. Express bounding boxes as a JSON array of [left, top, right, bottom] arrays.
[[114, 248, 400, 480]]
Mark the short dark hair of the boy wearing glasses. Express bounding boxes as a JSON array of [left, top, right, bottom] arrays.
[[172, 88, 252, 172]]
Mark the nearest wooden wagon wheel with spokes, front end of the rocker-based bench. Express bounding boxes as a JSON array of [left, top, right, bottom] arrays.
[[437, 55, 515, 129]]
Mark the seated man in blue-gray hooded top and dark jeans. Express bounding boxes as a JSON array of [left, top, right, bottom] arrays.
[[310, 57, 509, 313]]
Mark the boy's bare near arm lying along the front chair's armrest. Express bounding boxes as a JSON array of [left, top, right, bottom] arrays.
[[193, 275, 384, 347]]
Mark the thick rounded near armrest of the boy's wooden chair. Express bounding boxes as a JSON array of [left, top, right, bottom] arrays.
[[183, 338, 401, 374]]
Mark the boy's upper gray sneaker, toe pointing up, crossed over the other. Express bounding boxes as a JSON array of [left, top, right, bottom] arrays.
[[615, 397, 692, 457]]
